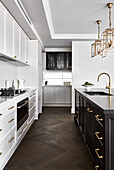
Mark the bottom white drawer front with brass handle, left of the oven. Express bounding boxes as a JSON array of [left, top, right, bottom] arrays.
[[0, 129, 16, 159]]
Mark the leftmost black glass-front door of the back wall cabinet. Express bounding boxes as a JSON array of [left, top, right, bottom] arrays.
[[46, 53, 56, 70]]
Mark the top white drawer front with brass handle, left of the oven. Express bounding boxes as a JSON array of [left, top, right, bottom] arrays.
[[0, 103, 15, 120]]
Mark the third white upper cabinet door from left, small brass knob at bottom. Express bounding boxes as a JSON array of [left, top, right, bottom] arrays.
[[13, 22, 20, 58]]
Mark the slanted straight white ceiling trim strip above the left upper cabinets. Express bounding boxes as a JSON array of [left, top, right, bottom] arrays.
[[14, 0, 44, 49]]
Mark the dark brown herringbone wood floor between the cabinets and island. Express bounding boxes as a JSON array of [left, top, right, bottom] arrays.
[[4, 108, 94, 170]]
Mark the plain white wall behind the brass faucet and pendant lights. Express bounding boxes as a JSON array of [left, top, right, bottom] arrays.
[[72, 41, 114, 113]]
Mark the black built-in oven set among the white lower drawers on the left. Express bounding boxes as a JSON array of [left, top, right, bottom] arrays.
[[17, 98, 29, 130]]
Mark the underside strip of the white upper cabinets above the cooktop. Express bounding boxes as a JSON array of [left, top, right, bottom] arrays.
[[0, 53, 29, 66]]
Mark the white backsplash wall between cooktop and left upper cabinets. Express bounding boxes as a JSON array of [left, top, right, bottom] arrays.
[[0, 61, 18, 88]]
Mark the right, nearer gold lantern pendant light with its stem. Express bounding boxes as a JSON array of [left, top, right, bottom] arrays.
[[102, 3, 114, 55]]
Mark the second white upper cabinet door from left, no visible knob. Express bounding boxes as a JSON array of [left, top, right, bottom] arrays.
[[5, 11, 14, 57]]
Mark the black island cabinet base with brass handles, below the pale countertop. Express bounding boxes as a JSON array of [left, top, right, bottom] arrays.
[[74, 90, 114, 170]]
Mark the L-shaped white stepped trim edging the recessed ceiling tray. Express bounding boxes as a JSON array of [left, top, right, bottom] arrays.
[[42, 0, 97, 40]]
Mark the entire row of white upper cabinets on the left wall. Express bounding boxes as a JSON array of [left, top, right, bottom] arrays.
[[0, 3, 30, 66]]
